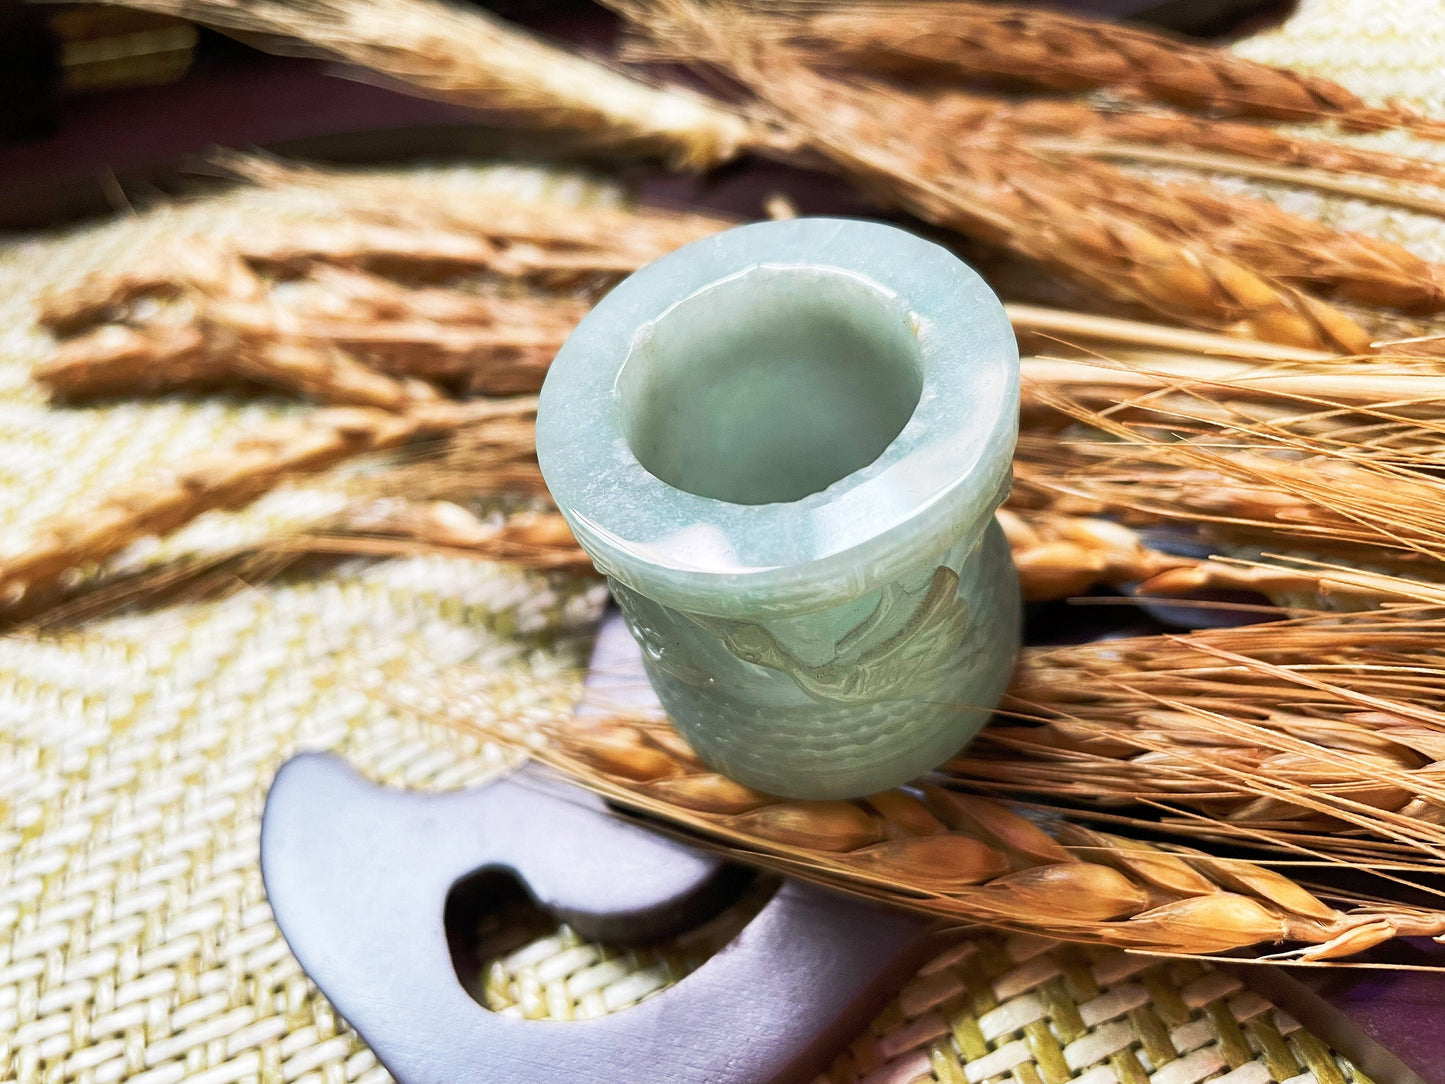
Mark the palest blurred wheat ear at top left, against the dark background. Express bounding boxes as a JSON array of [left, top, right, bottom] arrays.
[[66, 0, 775, 168]]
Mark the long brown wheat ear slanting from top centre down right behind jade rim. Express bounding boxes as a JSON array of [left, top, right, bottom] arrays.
[[615, 0, 1370, 353]]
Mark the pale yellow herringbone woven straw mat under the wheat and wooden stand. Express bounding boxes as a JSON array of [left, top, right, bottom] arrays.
[[0, 0, 1445, 1084]]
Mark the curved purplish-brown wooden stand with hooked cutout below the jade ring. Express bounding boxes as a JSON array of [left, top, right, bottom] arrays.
[[262, 754, 938, 1084]]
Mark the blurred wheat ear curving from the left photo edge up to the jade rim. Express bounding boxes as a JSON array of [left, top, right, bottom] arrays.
[[0, 399, 536, 603]]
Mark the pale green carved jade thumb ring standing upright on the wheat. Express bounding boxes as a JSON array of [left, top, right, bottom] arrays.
[[536, 218, 1020, 798]]
